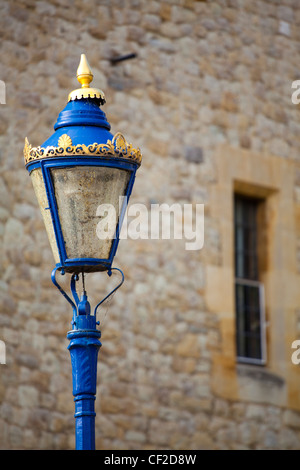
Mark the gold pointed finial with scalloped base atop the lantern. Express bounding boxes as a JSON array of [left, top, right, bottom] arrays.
[[68, 54, 105, 104]]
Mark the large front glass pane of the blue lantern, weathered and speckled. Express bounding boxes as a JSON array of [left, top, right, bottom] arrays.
[[51, 166, 130, 259]]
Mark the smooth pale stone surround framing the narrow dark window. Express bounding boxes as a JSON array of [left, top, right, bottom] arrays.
[[204, 144, 300, 410]]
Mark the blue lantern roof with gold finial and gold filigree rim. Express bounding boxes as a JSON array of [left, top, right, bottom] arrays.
[[24, 54, 142, 166]]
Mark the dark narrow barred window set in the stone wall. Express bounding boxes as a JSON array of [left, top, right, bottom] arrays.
[[234, 195, 266, 364]]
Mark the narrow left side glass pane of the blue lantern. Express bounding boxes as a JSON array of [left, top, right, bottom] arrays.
[[30, 168, 60, 263]]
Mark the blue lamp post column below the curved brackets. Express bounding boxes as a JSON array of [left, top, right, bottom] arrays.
[[67, 295, 101, 450]]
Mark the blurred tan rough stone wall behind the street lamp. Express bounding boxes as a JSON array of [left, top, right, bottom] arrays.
[[0, 0, 300, 449]]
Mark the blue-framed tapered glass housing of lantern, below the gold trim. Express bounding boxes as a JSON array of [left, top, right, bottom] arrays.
[[30, 157, 137, 272]]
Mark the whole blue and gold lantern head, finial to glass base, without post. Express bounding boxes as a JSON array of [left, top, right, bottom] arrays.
[[24, 54, 142, 273]]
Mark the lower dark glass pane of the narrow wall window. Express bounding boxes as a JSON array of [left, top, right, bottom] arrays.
[[235, 283, 262, 359]]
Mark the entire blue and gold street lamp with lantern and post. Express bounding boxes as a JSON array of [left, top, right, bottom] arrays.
[[24, 54, 142, 450]]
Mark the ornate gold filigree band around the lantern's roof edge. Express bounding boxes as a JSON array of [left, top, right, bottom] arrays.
[[24, 132, 142, 165]]
